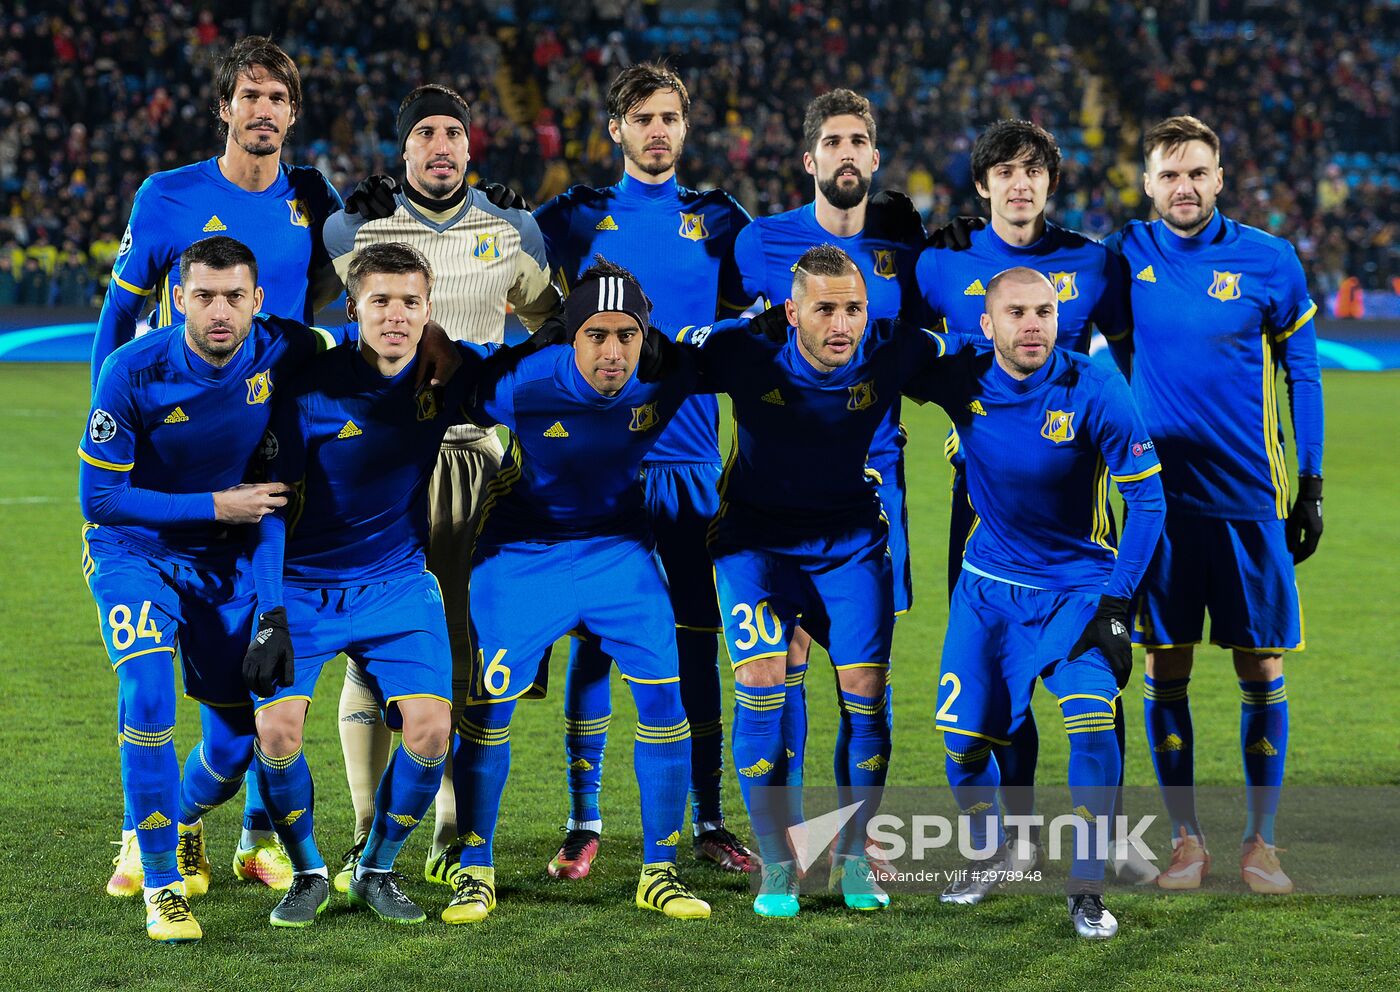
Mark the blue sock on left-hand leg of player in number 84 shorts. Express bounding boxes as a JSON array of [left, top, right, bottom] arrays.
[[116, 652, 181, 888]]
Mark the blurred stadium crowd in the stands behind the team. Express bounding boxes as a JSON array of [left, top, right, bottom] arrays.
[[0, 0, 1400, 306]]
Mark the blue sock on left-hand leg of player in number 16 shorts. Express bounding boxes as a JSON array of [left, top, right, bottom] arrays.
[[452, 700, 515, 867]]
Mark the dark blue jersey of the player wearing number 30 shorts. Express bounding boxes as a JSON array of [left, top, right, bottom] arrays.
[[685, 318, 944, 534]]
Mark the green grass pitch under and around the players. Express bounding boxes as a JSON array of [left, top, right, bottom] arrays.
[[0, 365, 1400, 992]]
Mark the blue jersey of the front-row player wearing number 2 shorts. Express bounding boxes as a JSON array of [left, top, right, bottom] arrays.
[[904, 341, 1163, 597]]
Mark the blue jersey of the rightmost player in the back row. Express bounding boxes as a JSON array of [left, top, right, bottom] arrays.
[[1105, 211, 1323, 520]]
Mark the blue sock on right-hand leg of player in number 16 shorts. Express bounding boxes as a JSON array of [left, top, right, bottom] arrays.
[[627, 681, 690, 865]]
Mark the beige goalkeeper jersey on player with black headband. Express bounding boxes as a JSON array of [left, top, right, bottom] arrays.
[[323, 189, 559, 441]]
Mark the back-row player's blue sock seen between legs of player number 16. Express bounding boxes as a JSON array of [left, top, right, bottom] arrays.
[[564, 638, 612, 826]]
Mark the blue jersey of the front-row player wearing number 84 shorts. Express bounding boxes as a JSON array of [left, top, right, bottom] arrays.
[[78, 313, 333, 564]]
